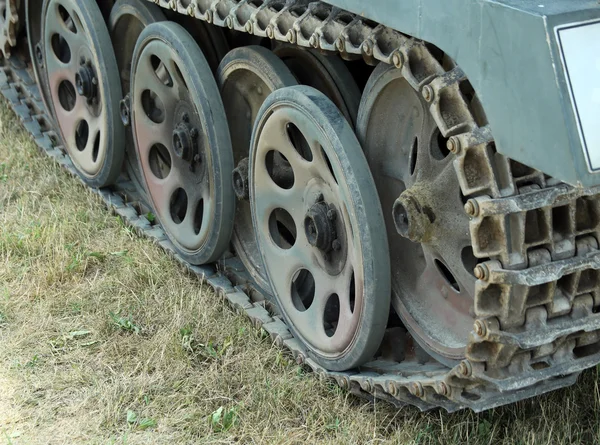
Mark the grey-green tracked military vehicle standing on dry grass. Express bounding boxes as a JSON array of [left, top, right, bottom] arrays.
[[0, 0, 600, 411]]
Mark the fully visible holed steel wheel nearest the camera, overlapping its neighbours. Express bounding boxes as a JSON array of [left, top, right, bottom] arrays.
[[250, 87, 389, 369]]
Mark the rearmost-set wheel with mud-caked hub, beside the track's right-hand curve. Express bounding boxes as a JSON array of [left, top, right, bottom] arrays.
[[358, 62, 477, 360]]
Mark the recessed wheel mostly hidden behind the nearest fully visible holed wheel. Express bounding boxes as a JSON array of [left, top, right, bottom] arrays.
[[217, 46, 297, 291]]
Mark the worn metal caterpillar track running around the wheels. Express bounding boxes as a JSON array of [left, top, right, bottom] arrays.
[[0, 0, 600, 412]]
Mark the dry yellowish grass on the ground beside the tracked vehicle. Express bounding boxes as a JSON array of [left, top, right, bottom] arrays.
[[0, 103, 600, 444]]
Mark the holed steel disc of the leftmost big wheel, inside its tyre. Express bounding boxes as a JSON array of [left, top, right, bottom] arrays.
[[44, 0, 112, 177]]
